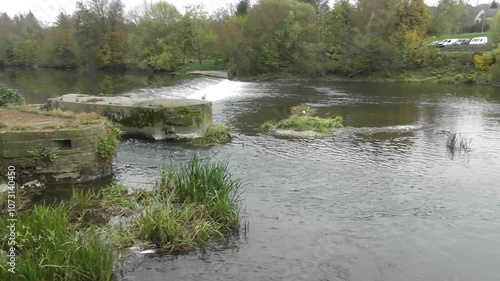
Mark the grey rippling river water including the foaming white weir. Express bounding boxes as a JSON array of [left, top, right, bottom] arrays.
[[0, 68, 500, 281]]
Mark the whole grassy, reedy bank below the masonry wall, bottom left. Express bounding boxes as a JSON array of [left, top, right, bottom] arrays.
[[0, 155, 241, 281]]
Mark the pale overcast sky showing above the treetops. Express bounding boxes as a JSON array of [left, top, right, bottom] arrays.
[[0, 0, 491, 22]]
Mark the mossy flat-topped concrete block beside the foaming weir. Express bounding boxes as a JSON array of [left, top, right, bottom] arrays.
[[48, 94, 212, 140]]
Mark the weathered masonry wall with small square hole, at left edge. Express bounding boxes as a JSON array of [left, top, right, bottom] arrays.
[[0, 124, 113, 185]]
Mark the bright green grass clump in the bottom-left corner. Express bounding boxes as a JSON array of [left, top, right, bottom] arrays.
[[0, 203, 118, 281]]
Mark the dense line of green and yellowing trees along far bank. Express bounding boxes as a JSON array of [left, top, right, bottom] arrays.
[[0, 0, 480, 76]]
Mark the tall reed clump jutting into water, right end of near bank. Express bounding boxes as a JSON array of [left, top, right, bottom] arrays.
[[135, 155, 241, 251]]
